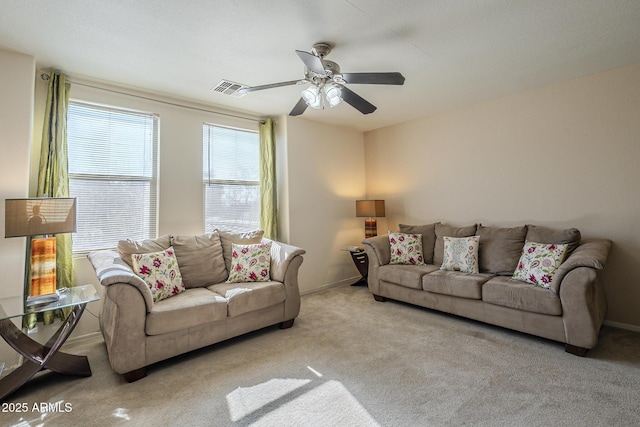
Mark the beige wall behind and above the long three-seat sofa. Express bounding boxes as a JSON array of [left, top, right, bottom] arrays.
[[365, 64, 640, 328]]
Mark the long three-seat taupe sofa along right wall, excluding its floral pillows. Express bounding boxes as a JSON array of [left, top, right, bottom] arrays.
[[363, 223, 611, 356]]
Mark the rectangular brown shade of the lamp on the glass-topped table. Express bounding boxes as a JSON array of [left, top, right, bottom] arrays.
[[4, 197, 76, 237]]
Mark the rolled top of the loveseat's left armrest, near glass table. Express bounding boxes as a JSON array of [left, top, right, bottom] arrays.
[[87, 250, 153, 313]]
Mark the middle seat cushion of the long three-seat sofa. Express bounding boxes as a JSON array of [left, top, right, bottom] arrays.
[[422, 270, 494, 299]]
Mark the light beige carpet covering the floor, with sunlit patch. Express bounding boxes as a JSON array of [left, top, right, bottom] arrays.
[[0, 286, 640, 426]]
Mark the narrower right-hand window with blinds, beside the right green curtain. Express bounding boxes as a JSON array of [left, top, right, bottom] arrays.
[[202, 123, 260, 232]]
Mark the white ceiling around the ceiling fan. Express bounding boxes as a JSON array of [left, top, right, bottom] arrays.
[[0, 0, 640, 131]]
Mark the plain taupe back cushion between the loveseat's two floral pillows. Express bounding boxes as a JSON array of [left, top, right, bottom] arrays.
[[171, 231, 228, 288]]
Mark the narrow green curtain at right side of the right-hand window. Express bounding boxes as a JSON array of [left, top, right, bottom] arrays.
[[259, 119, 278, 239]]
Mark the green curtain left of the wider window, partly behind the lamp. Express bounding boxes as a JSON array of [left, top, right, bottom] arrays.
[[25, 72, 74, 328]]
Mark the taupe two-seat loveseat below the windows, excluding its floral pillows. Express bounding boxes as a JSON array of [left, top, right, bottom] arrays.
[[89, 231, 305, 382]]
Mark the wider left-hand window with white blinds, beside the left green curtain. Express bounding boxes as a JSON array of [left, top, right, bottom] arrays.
[[67, 101, 158, 252]]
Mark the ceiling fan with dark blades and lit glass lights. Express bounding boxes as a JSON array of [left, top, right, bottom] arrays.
[[238, 43, 404, 116]]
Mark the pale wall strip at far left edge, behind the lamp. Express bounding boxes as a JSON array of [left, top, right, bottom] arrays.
[[0, 50, 35, 298]]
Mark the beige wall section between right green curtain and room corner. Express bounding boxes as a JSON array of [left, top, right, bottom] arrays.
[[286, 117, 366, 292]]
